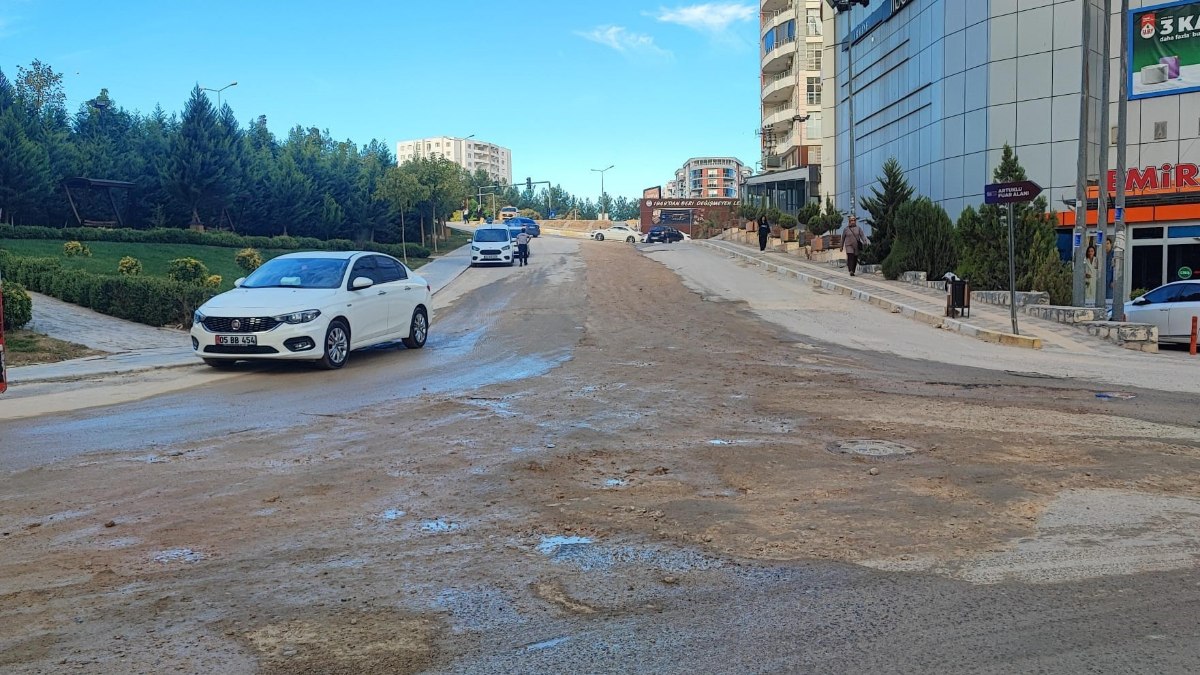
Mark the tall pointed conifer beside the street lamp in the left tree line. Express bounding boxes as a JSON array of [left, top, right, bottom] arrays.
[[166, 85, 230, 225]]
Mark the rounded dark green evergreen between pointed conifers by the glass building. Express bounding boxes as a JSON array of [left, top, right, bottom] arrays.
[[883, 197, 959, 279]]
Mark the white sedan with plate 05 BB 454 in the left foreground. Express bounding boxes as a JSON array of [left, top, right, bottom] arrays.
[[192, 251, 431, 369]]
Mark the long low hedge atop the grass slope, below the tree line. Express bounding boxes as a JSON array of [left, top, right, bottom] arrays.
[[0, 225, 430, 258]]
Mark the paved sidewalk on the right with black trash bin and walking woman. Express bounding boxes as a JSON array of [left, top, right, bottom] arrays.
[[696, 239, 1123, 354]]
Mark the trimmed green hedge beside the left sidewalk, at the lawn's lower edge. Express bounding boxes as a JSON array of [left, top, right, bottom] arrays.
[[0, 251, 214, 325]]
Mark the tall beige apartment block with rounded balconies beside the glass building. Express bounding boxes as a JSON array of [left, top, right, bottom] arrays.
[[758, 0, 824, 172]]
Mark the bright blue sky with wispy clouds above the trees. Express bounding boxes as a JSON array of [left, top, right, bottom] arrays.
[[0, 0, 760, 199]]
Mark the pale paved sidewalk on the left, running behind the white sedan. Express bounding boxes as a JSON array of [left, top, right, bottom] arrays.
[[8, 246, 470, 386]]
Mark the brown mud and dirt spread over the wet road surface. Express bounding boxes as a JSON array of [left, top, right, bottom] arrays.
[[0, 243, 1200, 673]]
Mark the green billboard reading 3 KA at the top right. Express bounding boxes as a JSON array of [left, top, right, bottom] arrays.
[[1126, 0, 1200, 98]]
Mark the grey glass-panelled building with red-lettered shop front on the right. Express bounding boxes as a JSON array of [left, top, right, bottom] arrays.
[[820, 0, 1200, 299]]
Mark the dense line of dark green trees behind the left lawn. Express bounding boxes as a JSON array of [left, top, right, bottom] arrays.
[[0, 60, 637, 246]]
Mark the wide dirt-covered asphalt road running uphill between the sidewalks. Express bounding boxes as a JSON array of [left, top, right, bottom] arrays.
[[0, 238, 1200, 673]]
